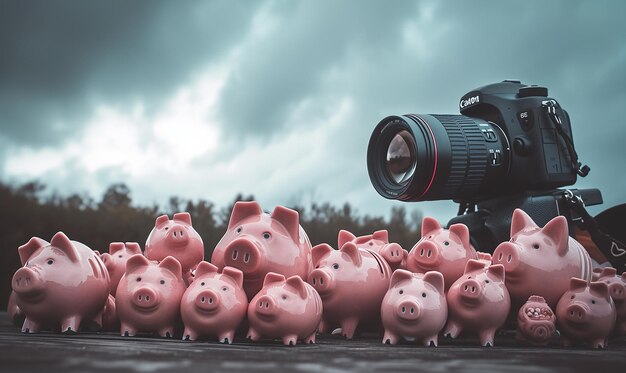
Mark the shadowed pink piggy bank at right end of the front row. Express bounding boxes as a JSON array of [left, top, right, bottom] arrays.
[[556, 277, 616, 348]]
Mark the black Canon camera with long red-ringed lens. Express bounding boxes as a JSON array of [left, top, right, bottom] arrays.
[[367, 80, 602, 251]]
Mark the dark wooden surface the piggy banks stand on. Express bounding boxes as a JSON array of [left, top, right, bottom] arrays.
[[0, 313, 626, 373]]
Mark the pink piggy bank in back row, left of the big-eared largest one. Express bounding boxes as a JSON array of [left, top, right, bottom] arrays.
[[145, 212, 204, 279]]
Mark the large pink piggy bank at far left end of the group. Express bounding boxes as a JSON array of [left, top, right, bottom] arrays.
[[12, 232, 109, 333]]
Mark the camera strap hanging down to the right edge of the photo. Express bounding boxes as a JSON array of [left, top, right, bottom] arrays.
[[563, 190, 626, 273]]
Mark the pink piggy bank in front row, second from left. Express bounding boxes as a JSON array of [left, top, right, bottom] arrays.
[[115, 254, 185, 338]]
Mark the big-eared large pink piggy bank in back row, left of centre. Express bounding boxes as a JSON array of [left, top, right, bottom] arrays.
[[211, 202, 311, 299]]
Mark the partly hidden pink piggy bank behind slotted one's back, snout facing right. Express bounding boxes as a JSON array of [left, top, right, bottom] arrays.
[[338, 229, 407, 270]]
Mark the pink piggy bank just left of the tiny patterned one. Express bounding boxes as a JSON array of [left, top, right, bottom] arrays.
[[444, 259, 511, 347]]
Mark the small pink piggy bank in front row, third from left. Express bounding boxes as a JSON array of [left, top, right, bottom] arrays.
[[180, 261, 248, 343]]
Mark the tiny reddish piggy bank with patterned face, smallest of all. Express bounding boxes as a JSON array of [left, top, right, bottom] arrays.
[[516, 295, 556, 346]]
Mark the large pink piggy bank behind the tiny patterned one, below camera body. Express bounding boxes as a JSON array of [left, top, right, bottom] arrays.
[[493, 209, 591, 309]]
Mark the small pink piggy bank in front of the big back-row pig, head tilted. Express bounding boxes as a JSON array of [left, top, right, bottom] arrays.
[[248, 272, 322, 346]]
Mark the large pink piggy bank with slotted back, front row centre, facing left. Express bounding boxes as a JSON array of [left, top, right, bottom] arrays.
[[308, 242, 391, 339]]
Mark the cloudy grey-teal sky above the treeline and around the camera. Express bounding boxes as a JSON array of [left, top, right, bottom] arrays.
[[0, 0, 626, 224]]
